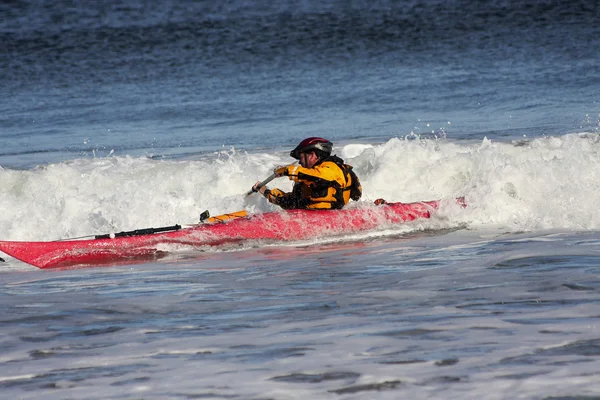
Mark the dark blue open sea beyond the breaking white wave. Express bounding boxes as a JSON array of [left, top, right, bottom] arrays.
[[0, 1, 600, 167]]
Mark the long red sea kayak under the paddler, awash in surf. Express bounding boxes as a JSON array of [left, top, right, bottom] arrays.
[[0, 199, 464, 268]]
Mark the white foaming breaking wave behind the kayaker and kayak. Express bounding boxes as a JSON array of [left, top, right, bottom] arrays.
[[0, 134, 600, 240]]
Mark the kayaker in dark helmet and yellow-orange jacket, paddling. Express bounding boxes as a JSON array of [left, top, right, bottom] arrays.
[[252, 137, 362, 210]]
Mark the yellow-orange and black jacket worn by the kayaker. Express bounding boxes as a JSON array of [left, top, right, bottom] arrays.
[[264, 156, 362, 210]]
